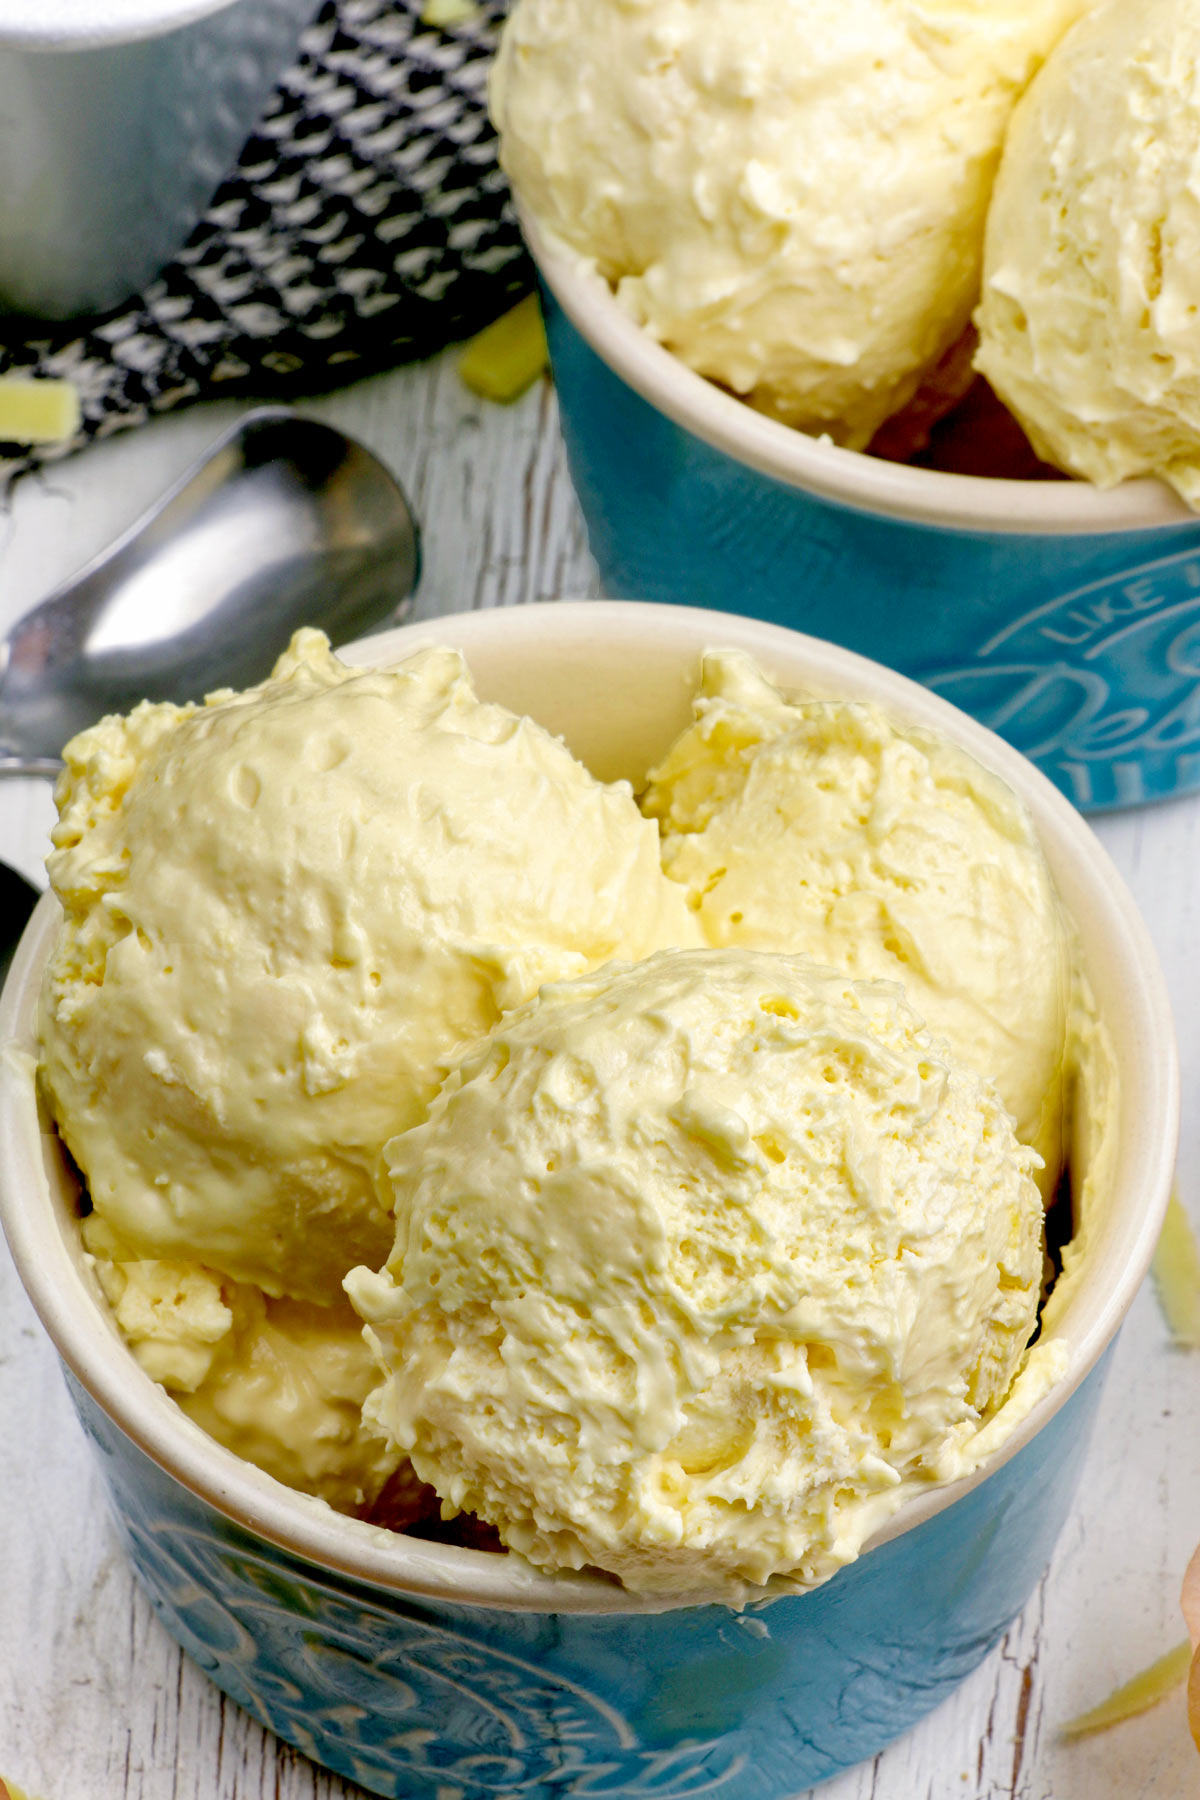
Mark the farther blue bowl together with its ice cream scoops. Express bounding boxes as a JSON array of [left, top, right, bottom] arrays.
[[493, 0, 1200, 810]]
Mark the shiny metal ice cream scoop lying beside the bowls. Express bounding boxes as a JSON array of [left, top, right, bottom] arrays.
[[0, 409, 419, 776]]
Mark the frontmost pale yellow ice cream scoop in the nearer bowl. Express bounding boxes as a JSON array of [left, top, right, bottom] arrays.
[[345, 950, 1042, 1598]]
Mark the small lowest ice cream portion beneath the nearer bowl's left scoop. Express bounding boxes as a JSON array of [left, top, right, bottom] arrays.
[[95, 1258, 399, 1512]]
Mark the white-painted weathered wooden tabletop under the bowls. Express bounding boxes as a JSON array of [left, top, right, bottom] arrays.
[[0, 358, 1200, 1800]]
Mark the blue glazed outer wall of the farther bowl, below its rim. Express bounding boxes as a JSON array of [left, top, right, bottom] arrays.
[[547, 293, 1200, 810]]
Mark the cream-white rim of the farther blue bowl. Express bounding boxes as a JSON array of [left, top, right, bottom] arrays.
[[518, 205, 1200, 536]]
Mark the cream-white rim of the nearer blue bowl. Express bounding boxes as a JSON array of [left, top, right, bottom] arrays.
[[0, 599, 1180, 1613]]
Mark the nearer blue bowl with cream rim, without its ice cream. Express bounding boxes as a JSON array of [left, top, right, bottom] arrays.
[[0, 601, 1178, 1800]]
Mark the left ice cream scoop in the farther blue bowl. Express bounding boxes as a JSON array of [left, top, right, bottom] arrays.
[[491, 0, 1087, 448]]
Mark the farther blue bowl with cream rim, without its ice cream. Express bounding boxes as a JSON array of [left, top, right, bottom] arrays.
[[525, 220, 1200, 810]]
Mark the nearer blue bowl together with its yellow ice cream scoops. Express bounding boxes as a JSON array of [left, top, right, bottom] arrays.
[[0, 603, 1178, 1800]]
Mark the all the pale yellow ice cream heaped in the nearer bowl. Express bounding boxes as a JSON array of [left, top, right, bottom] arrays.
[[41, 634, 1070, 1562]]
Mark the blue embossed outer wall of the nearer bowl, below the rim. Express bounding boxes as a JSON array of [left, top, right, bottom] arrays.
[[68, 1359, 1106, 1800]]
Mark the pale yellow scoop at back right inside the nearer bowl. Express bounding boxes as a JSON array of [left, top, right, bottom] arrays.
[[642, 652, 1072, 1195]]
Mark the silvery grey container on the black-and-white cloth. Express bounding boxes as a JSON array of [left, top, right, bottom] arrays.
[[0, 0, 315, 319]]
